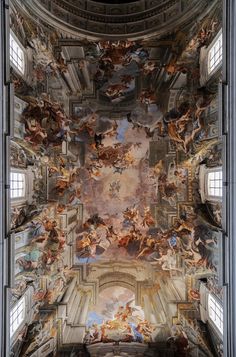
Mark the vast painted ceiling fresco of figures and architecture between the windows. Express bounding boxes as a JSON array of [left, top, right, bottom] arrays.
[[10, 2, 223, 357]]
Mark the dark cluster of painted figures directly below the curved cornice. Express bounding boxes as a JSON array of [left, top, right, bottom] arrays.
[[90, 41, 156, 104]]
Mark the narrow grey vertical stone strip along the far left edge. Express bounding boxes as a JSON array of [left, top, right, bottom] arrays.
[[0, 0, 10, 357]]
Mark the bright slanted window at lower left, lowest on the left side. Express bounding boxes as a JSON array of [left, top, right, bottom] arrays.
[[9, 295, 27, 340]]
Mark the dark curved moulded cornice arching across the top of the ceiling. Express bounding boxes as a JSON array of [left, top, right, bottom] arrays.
[[13, 0, 210, 41]]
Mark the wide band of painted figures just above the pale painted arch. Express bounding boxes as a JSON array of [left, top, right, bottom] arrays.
[[76, 208, 218, 271]]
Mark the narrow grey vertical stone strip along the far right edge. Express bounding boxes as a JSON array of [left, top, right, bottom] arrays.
[[224, 0, 236, 357]]
